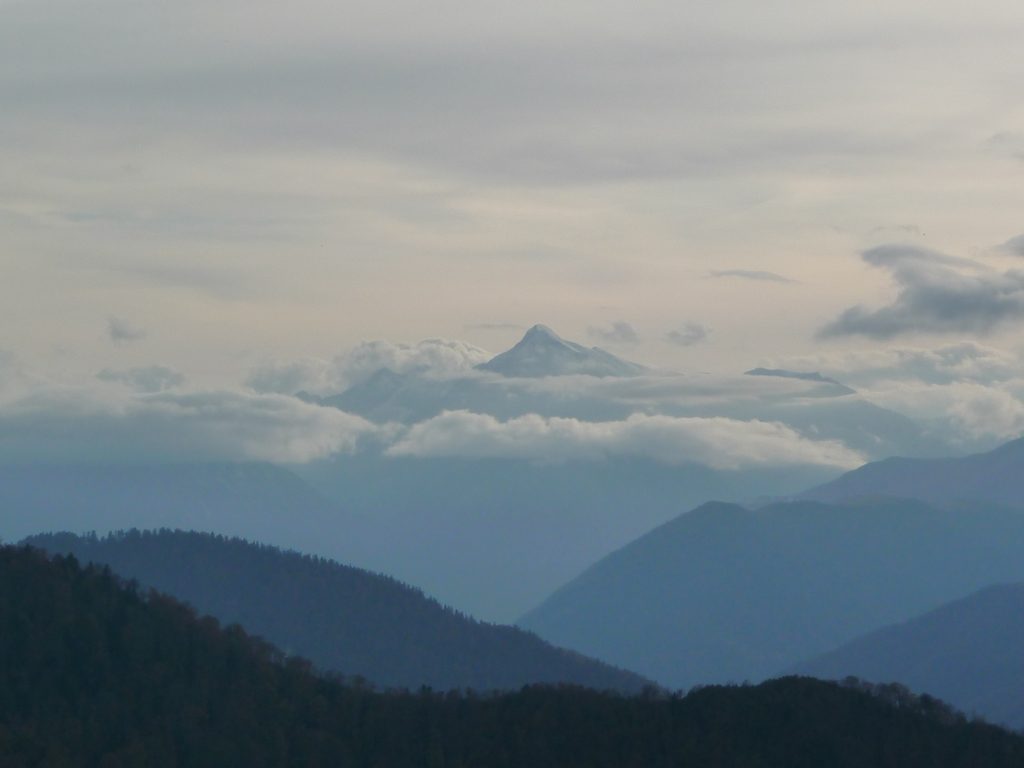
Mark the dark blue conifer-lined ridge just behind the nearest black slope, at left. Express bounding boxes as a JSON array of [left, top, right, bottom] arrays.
[[26, 530, 646, 692]]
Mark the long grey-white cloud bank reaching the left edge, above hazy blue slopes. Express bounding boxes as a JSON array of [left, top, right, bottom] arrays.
[[0, 389, 378, 463]]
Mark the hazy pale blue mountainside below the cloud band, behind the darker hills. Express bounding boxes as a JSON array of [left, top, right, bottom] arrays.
[[0, 453, 833, 623]]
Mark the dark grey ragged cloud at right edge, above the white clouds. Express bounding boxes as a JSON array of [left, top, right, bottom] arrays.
[[818, 245, 1024, 339]]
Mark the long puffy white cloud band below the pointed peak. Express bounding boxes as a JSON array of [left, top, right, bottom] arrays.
[[387, 411, 864, 470]]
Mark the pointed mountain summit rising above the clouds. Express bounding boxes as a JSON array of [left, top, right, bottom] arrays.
[[477, 326, 647, 379]]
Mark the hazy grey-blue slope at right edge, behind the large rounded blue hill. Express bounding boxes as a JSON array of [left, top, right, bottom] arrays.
[[802, 438, 1024, 507]]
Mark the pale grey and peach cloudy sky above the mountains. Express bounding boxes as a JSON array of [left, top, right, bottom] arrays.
[[0, 0, 1024, 466]]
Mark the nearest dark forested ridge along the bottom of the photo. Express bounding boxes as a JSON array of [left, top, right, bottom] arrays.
[[8, 548, 1024, 768]]
